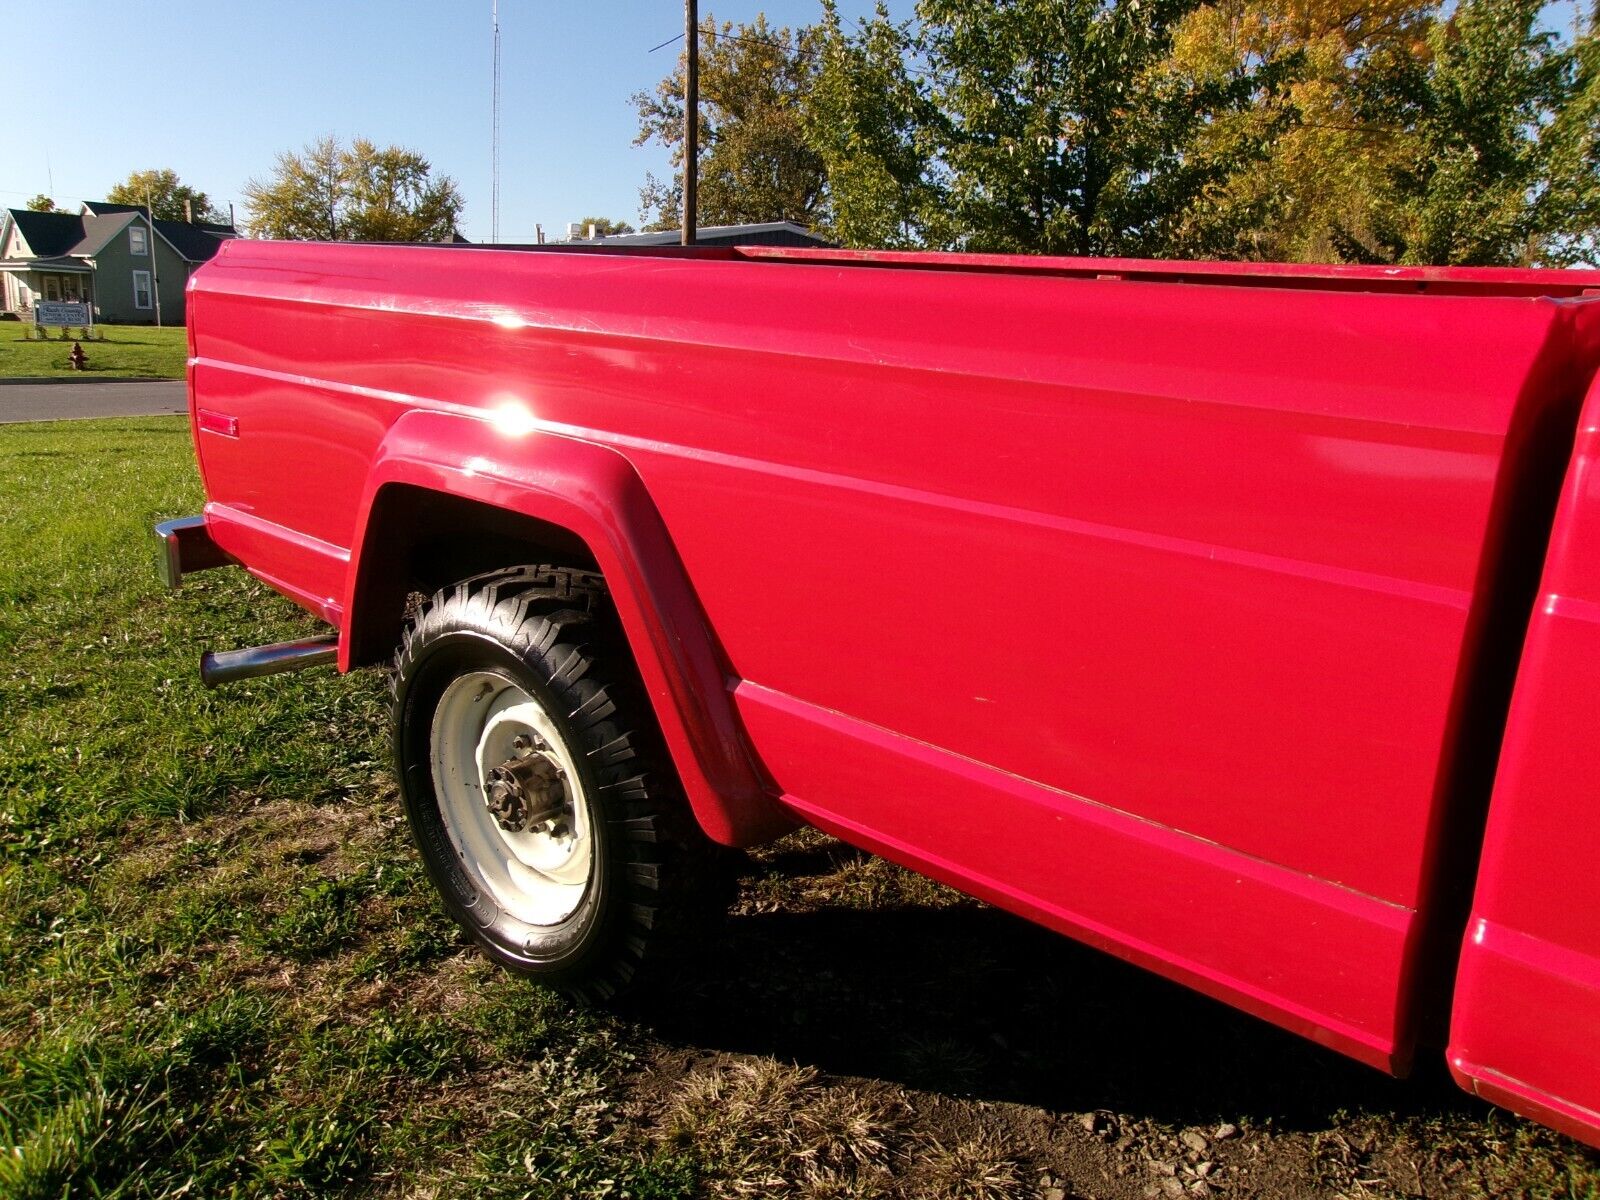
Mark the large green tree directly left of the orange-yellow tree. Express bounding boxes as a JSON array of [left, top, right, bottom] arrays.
[[917, 0, 1280, 254]]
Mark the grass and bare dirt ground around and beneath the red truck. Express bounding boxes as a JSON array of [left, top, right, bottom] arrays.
[[0, 418, 1600, 1200]]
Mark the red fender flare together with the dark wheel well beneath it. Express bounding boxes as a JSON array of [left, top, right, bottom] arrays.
[[339, 411, 795, 845]]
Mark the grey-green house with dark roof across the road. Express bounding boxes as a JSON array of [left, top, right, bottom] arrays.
[[0, 200, 237, 325]]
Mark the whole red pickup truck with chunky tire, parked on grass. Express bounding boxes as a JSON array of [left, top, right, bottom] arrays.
[[160, 242, 1600, 1144]]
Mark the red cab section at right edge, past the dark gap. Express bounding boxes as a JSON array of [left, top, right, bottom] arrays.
[[1450, 376, 1600, 1146]]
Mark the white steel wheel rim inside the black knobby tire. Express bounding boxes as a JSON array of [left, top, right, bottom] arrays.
[[432, 670, 594, 925]]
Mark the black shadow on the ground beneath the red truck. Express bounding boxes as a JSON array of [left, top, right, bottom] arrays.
[[629, 864, 1486, 1130]]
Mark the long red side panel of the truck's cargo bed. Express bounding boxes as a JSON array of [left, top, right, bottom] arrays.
[[190, 242, 1600, 1107]]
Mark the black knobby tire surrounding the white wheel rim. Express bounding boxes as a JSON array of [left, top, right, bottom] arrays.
[[394, 566, 728, 1002]]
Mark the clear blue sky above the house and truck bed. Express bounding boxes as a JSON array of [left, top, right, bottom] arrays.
[[0, 0, 876, 242]]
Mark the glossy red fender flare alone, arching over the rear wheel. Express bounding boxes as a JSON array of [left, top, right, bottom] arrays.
[[339, 411, 794, 845]]
